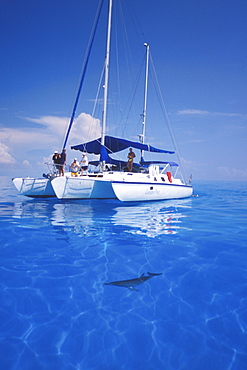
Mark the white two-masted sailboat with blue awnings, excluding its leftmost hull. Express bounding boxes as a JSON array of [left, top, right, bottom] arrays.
[[51, 0, 193, 202]]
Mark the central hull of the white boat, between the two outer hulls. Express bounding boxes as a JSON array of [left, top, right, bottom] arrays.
[[52, 176, 116, 199]]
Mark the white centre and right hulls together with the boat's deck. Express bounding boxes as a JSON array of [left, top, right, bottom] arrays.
[[51, 172, 193, 202]]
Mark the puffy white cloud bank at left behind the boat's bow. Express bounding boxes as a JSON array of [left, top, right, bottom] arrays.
[[0, 113, 101, 176]]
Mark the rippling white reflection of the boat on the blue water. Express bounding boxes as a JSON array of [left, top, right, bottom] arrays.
[[10, 199, 191, 238]]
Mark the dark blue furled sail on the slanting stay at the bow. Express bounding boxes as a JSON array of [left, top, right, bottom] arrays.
[[63, 0, 104, 148]]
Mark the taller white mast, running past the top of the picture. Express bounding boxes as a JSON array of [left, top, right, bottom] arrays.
[[101, 0, 112, 170]]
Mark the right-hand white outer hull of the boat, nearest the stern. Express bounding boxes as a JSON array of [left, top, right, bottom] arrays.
[[112, 182, 193, 202]]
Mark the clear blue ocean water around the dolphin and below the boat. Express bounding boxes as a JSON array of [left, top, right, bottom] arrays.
[[0, 177, 247, 370]]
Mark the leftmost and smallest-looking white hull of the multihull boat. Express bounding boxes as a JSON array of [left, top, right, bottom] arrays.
[[12, 177, 56, 198]]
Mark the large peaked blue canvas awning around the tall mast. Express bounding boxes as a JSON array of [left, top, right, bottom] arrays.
[[71, 136, 175, 155]]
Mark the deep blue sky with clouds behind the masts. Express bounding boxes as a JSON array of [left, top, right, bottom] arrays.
[[0, 0, 247, 181]]
